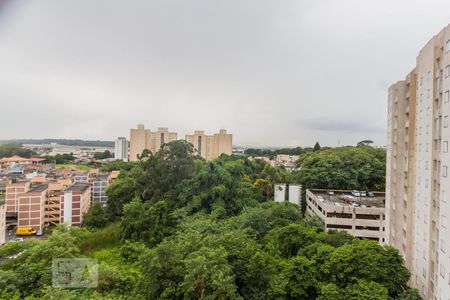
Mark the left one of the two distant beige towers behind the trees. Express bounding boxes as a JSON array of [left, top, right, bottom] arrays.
[[130, 124, 177, 161]]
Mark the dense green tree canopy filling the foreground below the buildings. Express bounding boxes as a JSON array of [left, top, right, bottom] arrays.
[[0, 142, 420, 300]]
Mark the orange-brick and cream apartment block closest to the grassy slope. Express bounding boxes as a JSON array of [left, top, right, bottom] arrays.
[[61, 182, 91, 226]]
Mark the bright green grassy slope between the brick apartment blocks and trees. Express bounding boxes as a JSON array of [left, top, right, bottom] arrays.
[[78, 223, 120, 255]]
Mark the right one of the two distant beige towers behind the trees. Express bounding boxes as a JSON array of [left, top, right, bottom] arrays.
[[186, 129, 233, 160]]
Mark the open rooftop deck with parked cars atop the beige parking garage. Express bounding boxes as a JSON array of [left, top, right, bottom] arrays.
[[309, 189, 386, 208]]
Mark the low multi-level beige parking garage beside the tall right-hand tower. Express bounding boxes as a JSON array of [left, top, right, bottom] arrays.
[[306, 189, 385, 243]]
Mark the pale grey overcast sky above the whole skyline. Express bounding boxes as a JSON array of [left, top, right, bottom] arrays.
[[0, 0, 450, 146]]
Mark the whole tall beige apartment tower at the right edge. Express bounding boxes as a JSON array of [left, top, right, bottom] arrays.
[[386, 26, 450, 299]]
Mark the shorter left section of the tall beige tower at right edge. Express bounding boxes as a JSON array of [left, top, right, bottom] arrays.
[[386, 70, 417, 269]]
